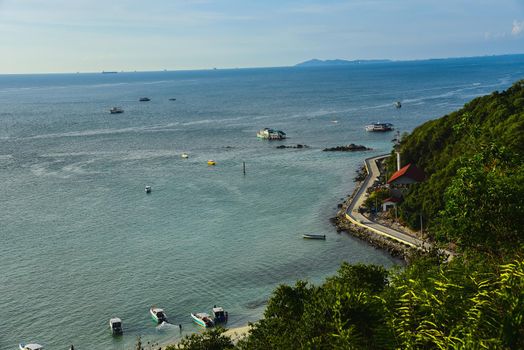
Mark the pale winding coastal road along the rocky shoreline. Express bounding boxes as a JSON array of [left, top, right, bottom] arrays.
[[346, 154, 431, 249]]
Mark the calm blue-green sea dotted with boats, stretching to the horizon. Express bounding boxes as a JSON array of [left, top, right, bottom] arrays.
[[0, 56, 524, 349]]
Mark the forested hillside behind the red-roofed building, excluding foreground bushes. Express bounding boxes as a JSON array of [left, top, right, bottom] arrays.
[[389, 81, 524, 246]]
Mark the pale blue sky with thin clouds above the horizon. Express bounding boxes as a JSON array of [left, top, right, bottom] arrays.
[[0, 0, 524, 73]]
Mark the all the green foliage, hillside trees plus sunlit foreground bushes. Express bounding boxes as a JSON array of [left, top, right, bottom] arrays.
[[170, 81, 524, 350]]
